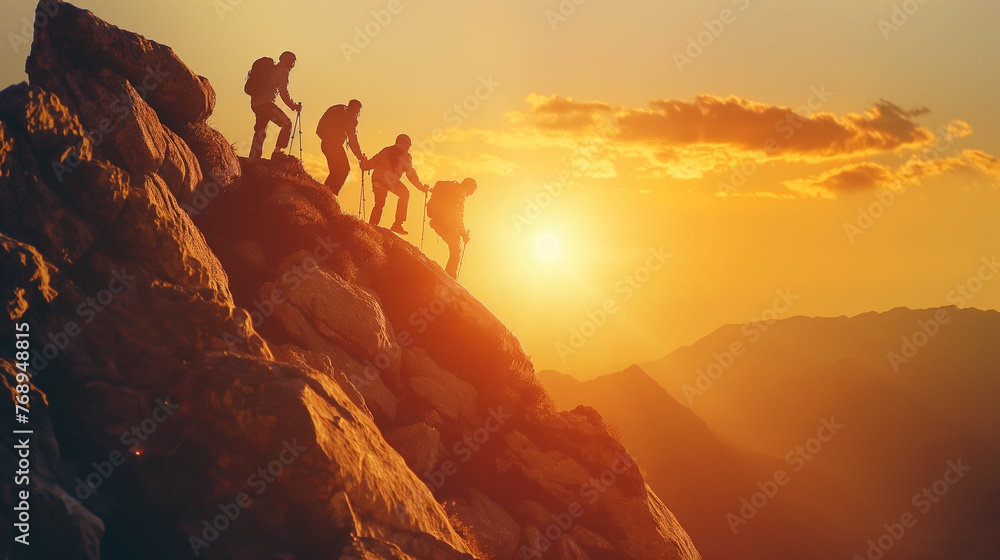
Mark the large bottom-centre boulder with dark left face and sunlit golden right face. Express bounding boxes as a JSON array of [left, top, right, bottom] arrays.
[[173, 355, 476, 559]]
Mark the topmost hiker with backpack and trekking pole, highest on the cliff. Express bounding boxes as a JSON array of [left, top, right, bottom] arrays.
[[243, 51, 302, 160]]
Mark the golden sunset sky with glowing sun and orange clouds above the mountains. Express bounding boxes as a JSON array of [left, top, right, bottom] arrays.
[[0, 0, 1000, 377]]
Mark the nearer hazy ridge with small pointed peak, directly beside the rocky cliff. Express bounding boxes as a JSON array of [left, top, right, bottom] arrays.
[[538, 366, 861, 560]]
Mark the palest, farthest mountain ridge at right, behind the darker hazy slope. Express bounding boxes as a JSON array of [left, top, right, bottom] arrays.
[[643, 307, 1000, 446]]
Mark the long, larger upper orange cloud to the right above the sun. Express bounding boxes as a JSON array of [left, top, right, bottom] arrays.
[[468, 90, 944, 179]]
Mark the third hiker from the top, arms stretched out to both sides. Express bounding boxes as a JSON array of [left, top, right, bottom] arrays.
[[361, 134, 430, 235]]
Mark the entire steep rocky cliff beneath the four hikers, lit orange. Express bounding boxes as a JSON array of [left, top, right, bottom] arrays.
[[0, 0, 699, 560]]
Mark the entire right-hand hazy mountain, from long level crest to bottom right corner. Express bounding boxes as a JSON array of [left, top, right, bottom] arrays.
[[645, 307, 1000, 558]]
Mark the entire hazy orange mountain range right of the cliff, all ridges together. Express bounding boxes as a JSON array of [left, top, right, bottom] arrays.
[[539, 307, 1000, 560]]
